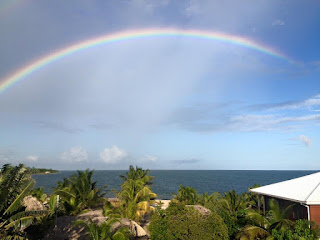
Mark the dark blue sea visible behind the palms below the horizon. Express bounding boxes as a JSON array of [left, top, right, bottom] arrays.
[[32, 170, 317, 199]]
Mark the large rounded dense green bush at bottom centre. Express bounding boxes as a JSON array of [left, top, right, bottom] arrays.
[[149, 203, 229, 240]]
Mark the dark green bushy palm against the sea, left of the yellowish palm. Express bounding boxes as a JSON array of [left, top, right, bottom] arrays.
[[54, 169, 107, 215]]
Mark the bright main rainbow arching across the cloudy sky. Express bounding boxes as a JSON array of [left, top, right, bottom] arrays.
[[0, 28, 292, 93]]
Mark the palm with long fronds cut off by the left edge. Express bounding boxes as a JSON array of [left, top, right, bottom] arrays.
[[0, 164, 47, 239]]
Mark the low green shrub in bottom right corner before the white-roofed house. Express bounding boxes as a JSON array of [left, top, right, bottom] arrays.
[[270, 220, 319, 240]]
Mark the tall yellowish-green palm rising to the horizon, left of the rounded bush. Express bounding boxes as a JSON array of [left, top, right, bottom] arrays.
[[117, 166, 157, 222]]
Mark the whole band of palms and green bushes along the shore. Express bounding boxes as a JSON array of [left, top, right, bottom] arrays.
[[0, 164, 319, 240]]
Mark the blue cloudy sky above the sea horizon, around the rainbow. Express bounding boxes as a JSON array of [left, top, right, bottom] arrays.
[[0, 0, 320, 170]]
